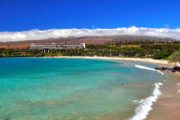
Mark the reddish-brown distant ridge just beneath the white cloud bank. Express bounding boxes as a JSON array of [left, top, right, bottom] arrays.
[[0, 35, 177, 49]]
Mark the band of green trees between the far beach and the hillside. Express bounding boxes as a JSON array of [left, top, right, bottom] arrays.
[[0, 42, 180, 62]]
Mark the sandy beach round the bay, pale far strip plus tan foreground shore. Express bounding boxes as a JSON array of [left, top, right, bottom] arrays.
[[48, 56, 180, 120]]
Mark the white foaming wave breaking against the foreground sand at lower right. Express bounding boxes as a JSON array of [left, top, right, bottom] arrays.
[[129, 83, 162, 120]]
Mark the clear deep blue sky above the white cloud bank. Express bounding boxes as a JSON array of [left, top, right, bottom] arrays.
[[0, 0, 180, 32]]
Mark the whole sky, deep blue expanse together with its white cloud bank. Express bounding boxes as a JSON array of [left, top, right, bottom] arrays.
[[0, 0, 180, 42]]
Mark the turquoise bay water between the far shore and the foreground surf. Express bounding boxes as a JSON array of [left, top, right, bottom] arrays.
[[0, 58, 163, 120]]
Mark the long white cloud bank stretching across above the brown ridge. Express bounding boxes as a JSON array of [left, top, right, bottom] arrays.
[[0, 27, 180, 42]]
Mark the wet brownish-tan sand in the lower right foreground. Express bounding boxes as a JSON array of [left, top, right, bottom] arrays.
[[147, 73, 180, 120]]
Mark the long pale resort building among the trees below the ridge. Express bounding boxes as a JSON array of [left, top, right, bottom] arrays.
[[29, 43, 86, 52]]
